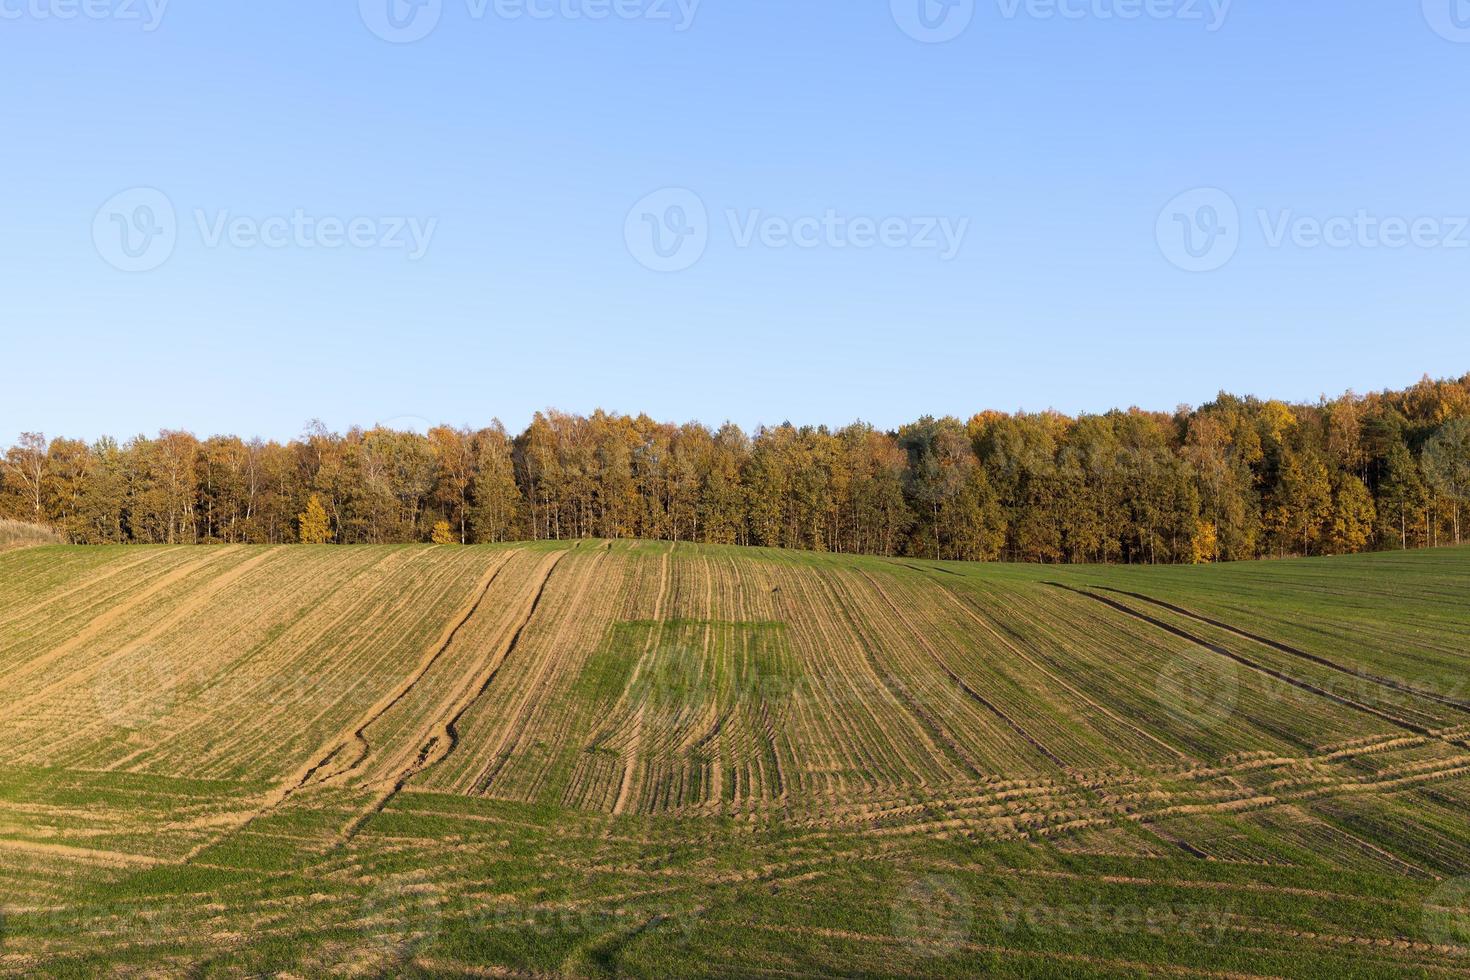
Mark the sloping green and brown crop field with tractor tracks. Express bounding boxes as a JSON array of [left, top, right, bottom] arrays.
[[0, 541, 1470, 977]]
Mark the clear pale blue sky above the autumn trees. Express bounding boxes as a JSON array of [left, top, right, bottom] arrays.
[[0, 0, 1470, 439]]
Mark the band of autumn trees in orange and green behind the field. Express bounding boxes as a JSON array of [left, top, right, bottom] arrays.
[[0, 375, 1470, 563]]
